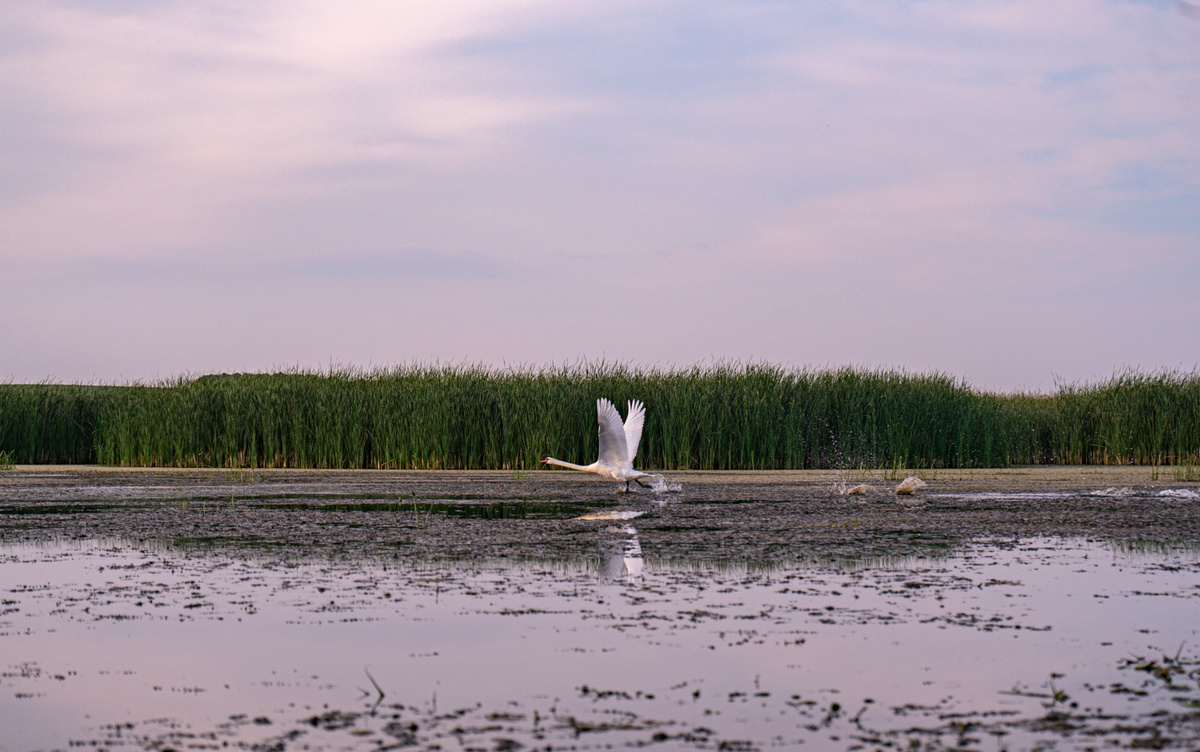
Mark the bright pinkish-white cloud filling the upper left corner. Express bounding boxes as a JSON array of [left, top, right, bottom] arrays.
[[0, 1, 585, 257]]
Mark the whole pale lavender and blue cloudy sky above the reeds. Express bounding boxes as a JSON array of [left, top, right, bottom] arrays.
[[0, 0, 1200, 392]]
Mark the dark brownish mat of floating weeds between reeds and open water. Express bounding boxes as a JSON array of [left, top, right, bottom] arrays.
[[0, 467, 1200, 564]]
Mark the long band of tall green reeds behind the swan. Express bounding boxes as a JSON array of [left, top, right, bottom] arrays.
[[0, 365, 1200, 469]]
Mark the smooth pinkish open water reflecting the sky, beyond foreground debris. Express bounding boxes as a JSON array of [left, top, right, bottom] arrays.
[[0, 537, 1200, 750]]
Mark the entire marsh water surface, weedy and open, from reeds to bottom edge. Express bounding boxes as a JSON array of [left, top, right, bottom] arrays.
[[0, 468, 1200, 751]]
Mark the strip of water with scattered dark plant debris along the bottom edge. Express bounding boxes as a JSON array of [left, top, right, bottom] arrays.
[[63, 655, 1200, 752]]
